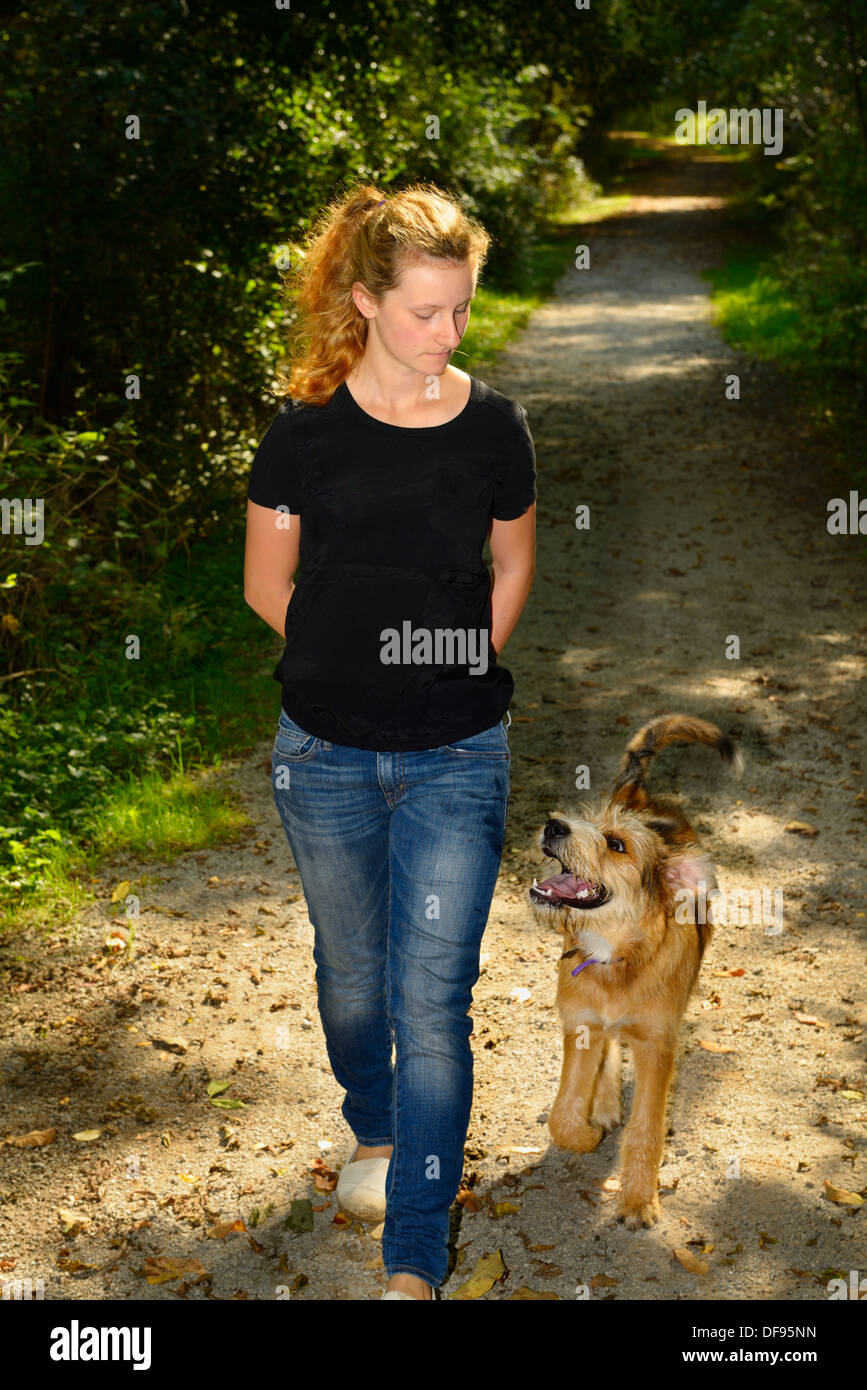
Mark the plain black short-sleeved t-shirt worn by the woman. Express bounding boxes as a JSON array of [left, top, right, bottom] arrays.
[[247, 377, 536, 752]]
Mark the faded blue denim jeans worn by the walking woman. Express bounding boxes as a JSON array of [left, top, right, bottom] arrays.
[[271, 710, 511, 1289]]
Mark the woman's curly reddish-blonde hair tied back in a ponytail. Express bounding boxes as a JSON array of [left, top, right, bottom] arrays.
[[276, 183, 490, 406]]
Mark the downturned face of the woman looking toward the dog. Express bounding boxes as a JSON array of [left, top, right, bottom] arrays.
[[353, 261, 475, 375]]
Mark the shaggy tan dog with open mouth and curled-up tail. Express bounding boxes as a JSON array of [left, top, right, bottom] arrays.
[[529, 714, 742, 1230]]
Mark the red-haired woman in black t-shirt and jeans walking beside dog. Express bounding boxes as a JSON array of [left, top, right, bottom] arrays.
[[245, 185, 536, 1298]]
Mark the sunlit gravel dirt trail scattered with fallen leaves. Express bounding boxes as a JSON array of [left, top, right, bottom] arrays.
[[0, 152, 867, 1300]]
